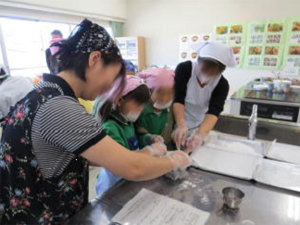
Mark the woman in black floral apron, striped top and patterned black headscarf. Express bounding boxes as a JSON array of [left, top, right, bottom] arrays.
[[0, 20, 191, 224]]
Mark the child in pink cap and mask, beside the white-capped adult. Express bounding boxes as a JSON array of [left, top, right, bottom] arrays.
[[136, 68, 175, 147]]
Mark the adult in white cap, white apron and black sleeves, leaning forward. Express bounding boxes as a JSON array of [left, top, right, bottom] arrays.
[[172, 42, 236, 152]]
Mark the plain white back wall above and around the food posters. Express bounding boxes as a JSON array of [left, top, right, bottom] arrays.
[[124, 0, 300, 100]]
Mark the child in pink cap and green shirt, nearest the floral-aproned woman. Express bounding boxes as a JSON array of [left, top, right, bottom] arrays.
[[96, 75, 167, 196]]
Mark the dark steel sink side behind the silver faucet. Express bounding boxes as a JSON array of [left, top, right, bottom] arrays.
[[214, 115, 300, 146]]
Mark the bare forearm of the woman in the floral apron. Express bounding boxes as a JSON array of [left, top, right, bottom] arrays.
[[81, 136, 173, 181]]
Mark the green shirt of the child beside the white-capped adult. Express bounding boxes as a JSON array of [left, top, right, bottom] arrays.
[[137, 103, 169, 147]]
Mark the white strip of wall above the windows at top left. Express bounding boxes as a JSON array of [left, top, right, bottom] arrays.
[[0, 0, 126, 21]]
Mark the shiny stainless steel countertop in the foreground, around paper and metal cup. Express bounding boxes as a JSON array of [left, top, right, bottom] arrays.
[[68, 168, 300, 225]]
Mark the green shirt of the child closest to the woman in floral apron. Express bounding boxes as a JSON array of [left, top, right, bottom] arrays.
[[103, 111, 139, 150]]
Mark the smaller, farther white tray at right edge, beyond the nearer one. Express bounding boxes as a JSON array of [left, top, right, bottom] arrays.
[[266, 143, 300, 165]]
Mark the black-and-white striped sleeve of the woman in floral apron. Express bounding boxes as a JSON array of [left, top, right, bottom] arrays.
[[34, 96, 106, 155]]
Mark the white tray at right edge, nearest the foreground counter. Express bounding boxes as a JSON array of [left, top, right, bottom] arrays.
[[254, 159, 300, 192]]
